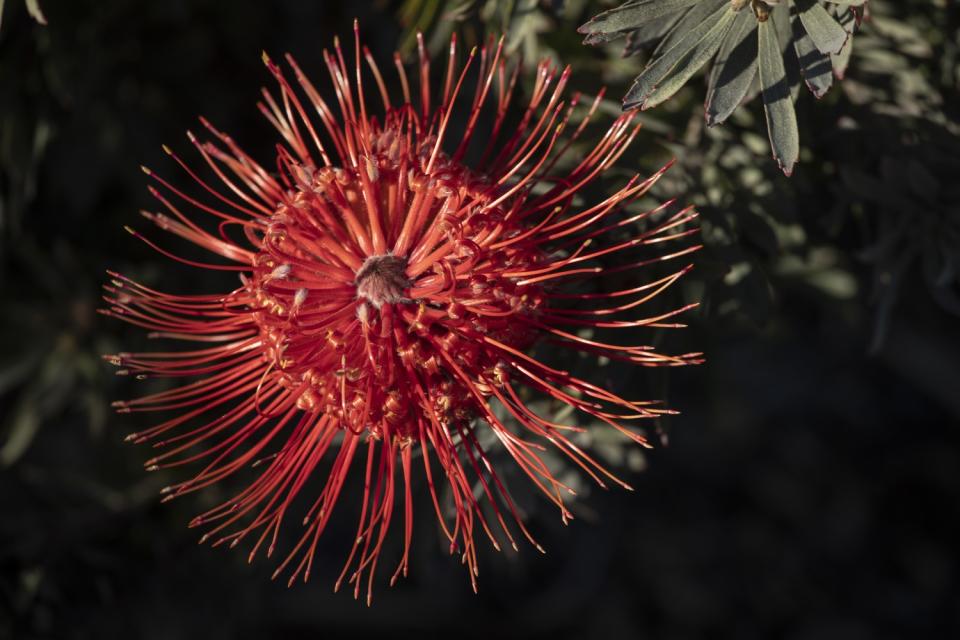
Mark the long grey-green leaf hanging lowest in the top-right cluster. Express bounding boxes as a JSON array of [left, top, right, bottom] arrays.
[[758, 20, 800, 176]]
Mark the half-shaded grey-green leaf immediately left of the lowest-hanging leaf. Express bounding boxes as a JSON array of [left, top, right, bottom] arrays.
[[706, 11, 757, 127]]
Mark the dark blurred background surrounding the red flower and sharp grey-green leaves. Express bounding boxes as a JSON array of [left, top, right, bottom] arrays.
[[0, 0, 960, 640]]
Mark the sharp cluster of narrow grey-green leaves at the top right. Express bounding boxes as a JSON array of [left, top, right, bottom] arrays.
[[580, 0, 866, 175]]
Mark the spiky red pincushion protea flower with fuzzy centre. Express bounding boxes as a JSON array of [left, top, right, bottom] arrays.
[[104, 20, 700, 602]]
